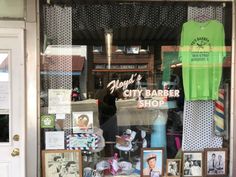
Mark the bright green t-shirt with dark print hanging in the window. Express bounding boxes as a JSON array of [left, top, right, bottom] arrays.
[[179, 20, 226, 100]]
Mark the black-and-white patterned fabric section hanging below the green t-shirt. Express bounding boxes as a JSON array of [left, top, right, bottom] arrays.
[[182, 101, 223, 151]]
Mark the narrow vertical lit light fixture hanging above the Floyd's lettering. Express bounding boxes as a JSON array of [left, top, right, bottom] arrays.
[[105, 30, 113, 69]]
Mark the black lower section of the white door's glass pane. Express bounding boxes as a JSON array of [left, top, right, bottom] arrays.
[[0, 114, 9, 142]]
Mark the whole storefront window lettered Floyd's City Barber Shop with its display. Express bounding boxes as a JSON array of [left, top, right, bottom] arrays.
[[39, 1, 232, 177]]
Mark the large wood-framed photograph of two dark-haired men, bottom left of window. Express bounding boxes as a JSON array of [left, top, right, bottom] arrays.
[[42, 150, 82, 177]]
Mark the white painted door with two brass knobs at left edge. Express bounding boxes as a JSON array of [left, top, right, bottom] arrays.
[[0, 28, 25, 177]]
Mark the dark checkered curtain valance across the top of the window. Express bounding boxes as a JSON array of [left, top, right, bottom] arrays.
[[72, 3, 187, 31]]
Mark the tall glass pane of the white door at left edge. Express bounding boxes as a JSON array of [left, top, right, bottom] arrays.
[[0, 53, 9, 142]]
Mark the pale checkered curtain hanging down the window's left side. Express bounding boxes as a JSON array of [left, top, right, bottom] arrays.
[[41, 5, 72, 135]]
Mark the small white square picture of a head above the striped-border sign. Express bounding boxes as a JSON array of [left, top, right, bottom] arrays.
[[72, 111, 93, 133]]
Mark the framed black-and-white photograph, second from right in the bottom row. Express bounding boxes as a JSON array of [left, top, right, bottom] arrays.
[[182, 151, 204, 177]]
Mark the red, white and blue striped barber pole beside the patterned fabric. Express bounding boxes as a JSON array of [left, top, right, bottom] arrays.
[[214, 89, 225, 136]]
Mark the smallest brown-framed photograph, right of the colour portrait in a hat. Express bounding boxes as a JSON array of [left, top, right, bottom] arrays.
[[166, 159, 181, 177]]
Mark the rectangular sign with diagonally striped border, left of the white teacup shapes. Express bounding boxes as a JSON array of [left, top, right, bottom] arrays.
[[66, 133, 100, 151]]
